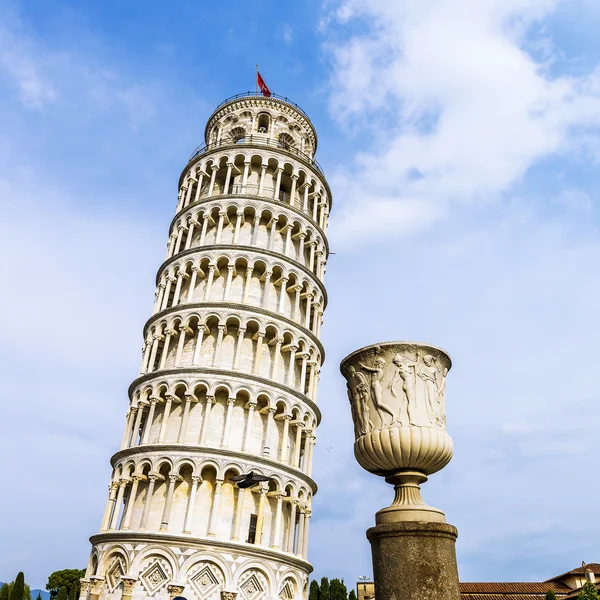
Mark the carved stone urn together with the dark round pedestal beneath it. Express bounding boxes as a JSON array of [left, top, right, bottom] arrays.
[[341, 342, 460, 600]]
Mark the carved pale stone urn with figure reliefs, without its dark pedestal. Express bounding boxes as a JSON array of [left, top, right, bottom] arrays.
[[340, 342, 453, 525]]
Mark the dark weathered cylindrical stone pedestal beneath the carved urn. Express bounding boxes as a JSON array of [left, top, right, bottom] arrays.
[[367, 521, 460, 600]]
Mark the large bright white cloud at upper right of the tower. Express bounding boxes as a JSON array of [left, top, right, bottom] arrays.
[[327, 0, 600, 244]]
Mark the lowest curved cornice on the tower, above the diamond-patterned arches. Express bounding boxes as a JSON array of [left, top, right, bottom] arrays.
[[90, 530, 313, 574]]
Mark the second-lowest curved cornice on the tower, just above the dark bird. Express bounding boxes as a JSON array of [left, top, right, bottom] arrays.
[[110, 444, 319, 496]]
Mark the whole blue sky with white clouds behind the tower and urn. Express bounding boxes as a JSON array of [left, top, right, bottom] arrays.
[[0, 0, 600, 587]]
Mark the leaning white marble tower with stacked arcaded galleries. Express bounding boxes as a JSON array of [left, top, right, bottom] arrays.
[[81, 94, 331, 600]]
